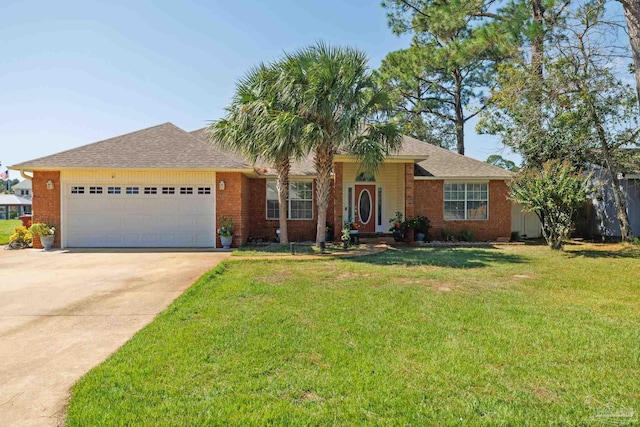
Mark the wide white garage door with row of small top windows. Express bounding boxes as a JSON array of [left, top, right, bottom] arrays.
[[63, 183, 216, 248]]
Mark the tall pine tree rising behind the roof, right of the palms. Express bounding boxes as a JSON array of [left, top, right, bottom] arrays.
[[379, 0, 510, 154]]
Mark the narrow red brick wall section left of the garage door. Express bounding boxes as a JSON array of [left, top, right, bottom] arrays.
[[31, 171, 62, 248]]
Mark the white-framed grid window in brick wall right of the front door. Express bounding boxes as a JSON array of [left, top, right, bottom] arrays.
[[444, 182, 489, 220]]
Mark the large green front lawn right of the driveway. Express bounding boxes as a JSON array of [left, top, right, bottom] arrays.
[[67, 245, 640, 426]]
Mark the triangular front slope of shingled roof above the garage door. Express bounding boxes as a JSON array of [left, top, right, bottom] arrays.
[[11, 123, 252, 170]]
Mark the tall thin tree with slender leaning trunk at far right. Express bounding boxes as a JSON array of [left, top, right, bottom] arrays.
[[552, 2, 640, 241]]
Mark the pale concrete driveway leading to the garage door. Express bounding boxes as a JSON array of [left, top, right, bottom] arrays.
[[0, 249, 229, 426]]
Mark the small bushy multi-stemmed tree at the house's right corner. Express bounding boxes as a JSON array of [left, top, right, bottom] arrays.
[[509, 160, 592, 249]]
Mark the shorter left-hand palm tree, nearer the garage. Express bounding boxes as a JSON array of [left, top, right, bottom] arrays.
[[207, 63, 304, 243]]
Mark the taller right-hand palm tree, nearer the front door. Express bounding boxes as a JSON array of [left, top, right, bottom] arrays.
[[280, 43, 401, 244]]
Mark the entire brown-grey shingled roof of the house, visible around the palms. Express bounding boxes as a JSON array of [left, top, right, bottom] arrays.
[[11, 123, 512, 179]]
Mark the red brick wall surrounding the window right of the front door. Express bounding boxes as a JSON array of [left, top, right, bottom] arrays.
[[414, 180, 511, 240]]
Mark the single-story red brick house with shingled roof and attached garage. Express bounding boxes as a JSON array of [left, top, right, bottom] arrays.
[[11, 123, 512, 248]]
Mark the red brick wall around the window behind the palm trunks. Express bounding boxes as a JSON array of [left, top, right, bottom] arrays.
[[249, 178, 334, 242]]
